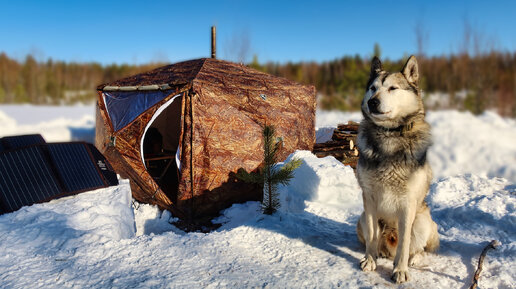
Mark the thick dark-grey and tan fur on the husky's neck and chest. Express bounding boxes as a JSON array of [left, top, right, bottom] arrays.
[[358, 119, 431, 208]]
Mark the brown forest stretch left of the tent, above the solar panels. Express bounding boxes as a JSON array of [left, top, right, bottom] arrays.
[[0, 53, 162, 104]]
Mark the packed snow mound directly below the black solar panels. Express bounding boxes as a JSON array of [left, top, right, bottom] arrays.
[[0, 180, 135, 256]]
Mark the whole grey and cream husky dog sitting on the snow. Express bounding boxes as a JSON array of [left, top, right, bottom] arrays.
[[357, 56, 439, 283]]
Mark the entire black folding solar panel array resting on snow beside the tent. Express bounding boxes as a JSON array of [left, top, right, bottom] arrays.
[[0, 135, 118, 214]]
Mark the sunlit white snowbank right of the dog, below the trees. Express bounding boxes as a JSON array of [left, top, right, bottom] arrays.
[[428, 111, 516, 182]]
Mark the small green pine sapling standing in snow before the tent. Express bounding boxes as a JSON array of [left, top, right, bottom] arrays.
[[237, 125, 301, 215]]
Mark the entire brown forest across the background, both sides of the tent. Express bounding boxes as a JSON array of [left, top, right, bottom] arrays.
[[0, 47, 516, 117]]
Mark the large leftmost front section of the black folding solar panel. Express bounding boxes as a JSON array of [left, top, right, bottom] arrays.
[[0, 146, 61, 213]]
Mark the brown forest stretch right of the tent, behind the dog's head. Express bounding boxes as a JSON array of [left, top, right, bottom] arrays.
[[250, 49, 516, 117]]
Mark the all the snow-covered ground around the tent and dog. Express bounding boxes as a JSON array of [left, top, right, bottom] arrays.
[[0, 106, 516, 288]]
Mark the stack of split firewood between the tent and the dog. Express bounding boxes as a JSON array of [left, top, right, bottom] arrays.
[[313, 121, 359, 168]]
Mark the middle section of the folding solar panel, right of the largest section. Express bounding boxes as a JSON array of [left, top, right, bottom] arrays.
[[48, 143, 106, 192]]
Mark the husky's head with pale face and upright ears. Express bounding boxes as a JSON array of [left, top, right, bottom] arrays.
[[362, 56, 424, 128]]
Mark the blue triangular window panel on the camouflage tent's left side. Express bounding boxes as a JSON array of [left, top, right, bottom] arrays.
[[104, 90, 171, 131]]
